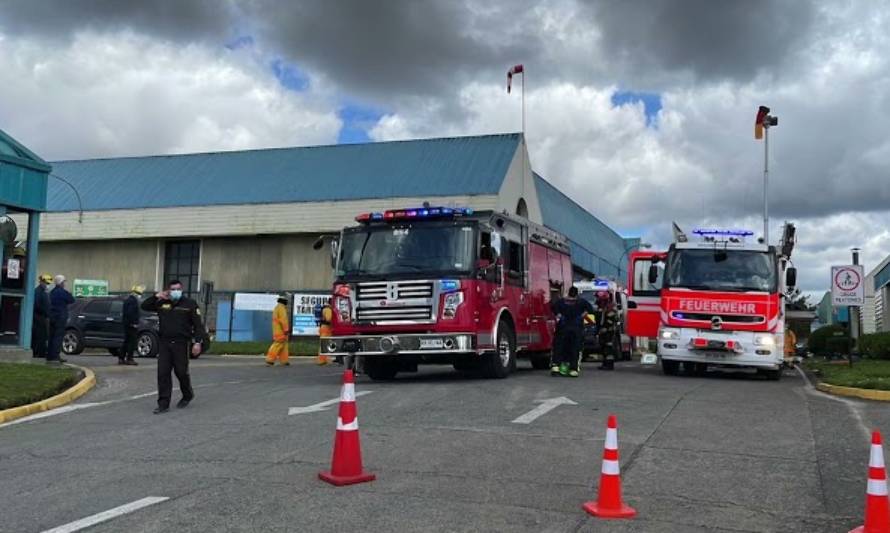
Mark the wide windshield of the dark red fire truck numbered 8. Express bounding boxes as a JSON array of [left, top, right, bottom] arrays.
[[337, 223, 476, 278]]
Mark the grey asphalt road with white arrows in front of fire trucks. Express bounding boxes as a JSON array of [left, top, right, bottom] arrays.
[[0, 356, 890, 533]]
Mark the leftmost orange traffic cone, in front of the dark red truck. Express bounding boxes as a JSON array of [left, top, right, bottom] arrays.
[[318, 370, 377, 487]]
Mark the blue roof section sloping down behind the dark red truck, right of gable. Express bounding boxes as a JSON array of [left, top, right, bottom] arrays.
[[535, 174, 639, 281]]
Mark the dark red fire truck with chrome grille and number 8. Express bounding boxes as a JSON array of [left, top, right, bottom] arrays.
[[320, 207, 572, 379]]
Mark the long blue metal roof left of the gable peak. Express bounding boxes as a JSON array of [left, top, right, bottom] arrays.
[[47, 133, 520, 211]]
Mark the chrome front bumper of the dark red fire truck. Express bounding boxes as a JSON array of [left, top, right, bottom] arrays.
[[319, 333, 478, 356]]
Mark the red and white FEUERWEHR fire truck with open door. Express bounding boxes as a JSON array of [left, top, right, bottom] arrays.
[[628, 224, 797, 379]]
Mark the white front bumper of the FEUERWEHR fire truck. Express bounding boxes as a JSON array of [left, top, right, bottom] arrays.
[[658, 328, 784, 370]]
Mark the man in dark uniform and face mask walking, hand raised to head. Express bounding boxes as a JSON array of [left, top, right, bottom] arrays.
[[142, 280, 207, 415]]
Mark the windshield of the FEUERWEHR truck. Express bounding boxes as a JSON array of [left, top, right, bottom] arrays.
[[664, 249, 777, 292]]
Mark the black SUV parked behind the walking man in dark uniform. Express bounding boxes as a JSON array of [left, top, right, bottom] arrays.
[[62, 296, 210, 357]]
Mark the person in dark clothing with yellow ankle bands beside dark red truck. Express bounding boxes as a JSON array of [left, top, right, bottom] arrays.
[[550, 287, 593, 378]]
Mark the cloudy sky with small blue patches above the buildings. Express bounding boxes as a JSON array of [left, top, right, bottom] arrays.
[[0, 0, 890, 291]]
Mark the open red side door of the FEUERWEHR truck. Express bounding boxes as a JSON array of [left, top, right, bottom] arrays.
[[625, 251, 664, 338]]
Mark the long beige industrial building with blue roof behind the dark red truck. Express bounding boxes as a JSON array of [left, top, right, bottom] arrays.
[[19, 133, 639, 332]]
